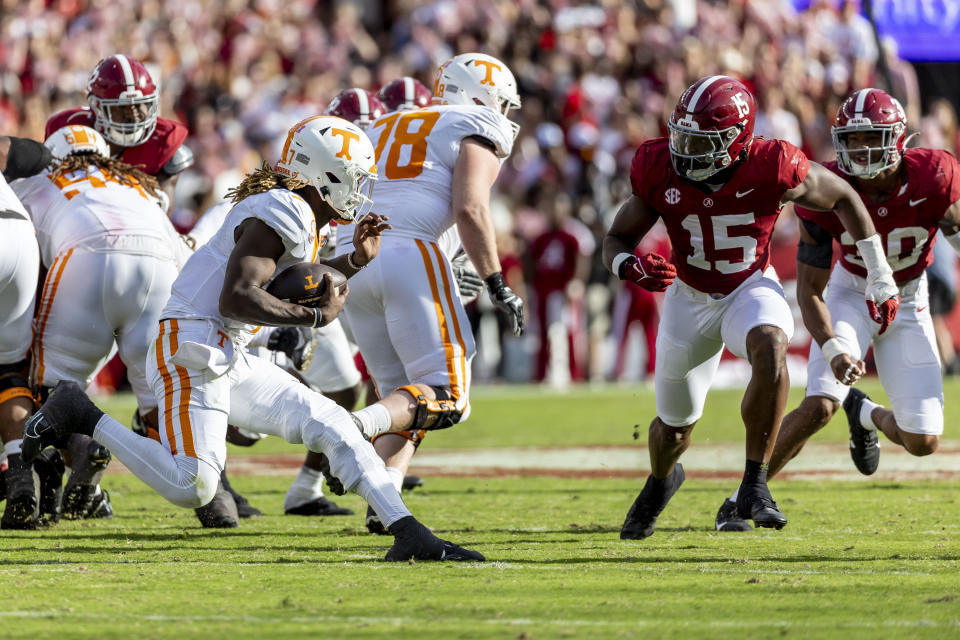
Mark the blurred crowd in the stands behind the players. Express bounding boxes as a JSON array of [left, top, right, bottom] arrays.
[[0, 0, 958, 384]]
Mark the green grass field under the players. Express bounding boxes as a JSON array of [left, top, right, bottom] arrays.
[[0, 381, 960, 639]]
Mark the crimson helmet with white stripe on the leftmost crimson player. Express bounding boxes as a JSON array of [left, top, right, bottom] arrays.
[[87, 53, 160, 147]]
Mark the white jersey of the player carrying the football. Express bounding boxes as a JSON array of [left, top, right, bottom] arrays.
[[161, 189, 320, 346]]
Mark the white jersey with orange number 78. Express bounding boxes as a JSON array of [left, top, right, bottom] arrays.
[[337, 105, 513, 253]]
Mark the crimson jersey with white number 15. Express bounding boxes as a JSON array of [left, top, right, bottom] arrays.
[[630, 138, 810, 294]]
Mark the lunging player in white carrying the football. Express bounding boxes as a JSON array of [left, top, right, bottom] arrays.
[[23, 116, 483, 561]]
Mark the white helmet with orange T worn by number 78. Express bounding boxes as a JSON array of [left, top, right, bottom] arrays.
[[433, 53, 520, 139]]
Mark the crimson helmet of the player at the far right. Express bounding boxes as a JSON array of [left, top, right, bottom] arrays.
[[830, 89, 907, 179]]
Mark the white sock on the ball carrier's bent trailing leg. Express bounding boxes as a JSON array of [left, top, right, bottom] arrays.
[[93, 415, 220, 509]]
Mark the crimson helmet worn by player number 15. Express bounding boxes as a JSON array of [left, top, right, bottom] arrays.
[[667, 76, 757, 181]]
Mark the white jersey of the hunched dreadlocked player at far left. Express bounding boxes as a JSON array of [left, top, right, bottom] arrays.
[[12, 165, 179, 266]]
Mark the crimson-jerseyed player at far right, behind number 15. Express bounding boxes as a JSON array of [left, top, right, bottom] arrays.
[[716, 89, 960, 531]]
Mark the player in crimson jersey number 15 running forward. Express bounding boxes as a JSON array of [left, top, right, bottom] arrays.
[[603, 76, 899, 539]]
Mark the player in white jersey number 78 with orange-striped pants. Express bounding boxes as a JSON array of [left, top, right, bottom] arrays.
[[337, 53, 523, 533]]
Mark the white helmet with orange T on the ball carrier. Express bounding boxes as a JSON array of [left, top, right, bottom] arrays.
[[274, 115, 377, 222]]
